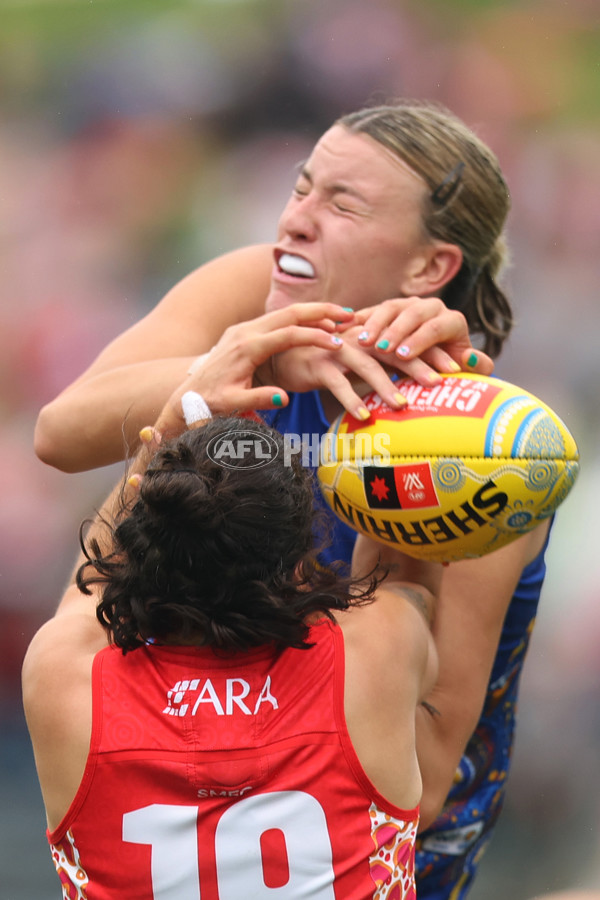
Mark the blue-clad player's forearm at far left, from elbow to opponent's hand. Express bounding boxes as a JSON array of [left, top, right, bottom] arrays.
[[34, 357, 192, 472]]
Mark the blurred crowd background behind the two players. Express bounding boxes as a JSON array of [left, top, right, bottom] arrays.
[[0, 0, 600, 900]]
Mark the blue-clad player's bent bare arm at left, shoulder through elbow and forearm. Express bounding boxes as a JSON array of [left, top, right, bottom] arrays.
[[34, 245, 272, 472]]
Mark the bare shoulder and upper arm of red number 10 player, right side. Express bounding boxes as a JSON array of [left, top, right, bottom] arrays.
[[337, 535, 442, 808]]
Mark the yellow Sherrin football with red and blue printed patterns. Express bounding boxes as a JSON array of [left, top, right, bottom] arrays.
[[317, 373, 579, 562]]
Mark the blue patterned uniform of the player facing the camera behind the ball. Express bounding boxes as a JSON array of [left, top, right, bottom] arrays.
[[261, 391, 547, 900]]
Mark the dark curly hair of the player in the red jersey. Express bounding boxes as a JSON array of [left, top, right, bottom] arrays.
[[77, 418, 377, 652]]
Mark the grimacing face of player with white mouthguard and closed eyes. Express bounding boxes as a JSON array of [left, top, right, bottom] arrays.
[[266, 125, 428, 311]]
